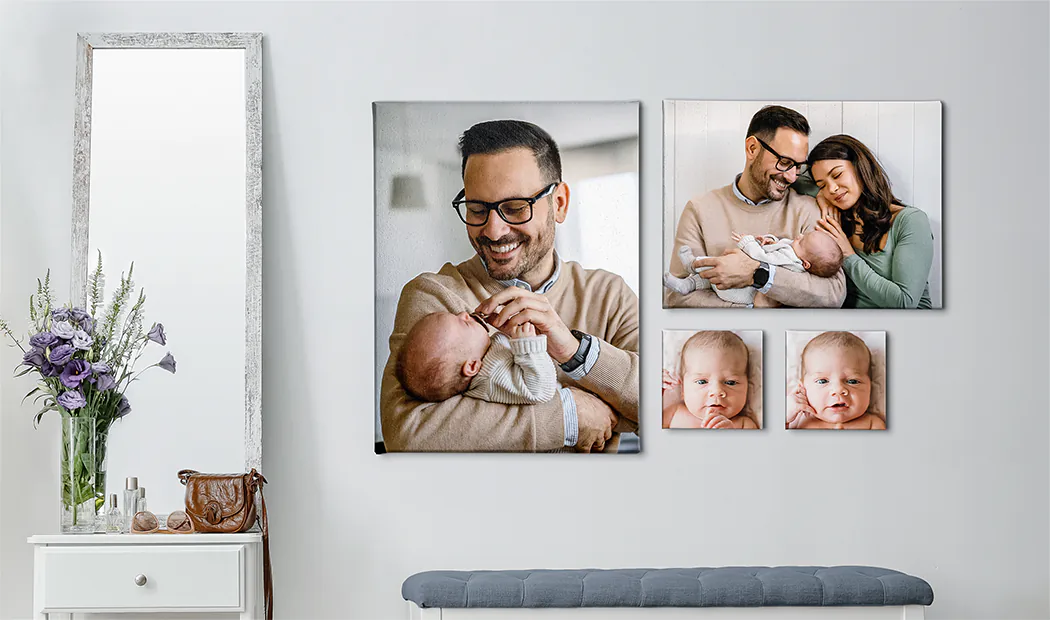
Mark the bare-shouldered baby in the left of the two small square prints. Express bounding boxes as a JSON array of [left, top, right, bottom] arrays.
[[664, 331, 758, 429]]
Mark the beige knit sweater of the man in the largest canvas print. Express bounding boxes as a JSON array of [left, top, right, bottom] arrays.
[[379, 255, 638, 452]]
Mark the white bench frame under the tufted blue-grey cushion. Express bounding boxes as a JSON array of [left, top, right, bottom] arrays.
[[407, 601, 926, 620]]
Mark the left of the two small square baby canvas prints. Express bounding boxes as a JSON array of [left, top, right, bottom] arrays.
[[663, 329, 762, 429]]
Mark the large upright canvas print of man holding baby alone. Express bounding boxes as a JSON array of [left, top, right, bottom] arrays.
[[374, 102, 639, 453]]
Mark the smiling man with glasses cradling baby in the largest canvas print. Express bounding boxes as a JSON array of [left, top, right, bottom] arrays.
[[380, 121, 638, 452]]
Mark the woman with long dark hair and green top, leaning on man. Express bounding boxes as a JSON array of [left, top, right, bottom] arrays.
[[809, 135, 933, 308]]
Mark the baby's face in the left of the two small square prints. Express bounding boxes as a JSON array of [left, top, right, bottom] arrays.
[[681, 347, 748, 419]]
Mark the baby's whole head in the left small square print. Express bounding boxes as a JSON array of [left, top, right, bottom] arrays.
[[678, 331, 748, 419]]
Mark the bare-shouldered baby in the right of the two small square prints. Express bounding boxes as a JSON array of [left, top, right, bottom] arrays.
[[786, 331, 886, 430]]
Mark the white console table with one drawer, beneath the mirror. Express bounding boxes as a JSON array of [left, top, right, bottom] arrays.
[[28, 533, 266, 620]]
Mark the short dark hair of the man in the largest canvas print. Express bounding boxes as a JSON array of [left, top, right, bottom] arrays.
[[459, 121, 562, 183]]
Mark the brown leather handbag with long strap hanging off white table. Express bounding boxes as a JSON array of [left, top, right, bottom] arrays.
[[179, 469, 273, 620]]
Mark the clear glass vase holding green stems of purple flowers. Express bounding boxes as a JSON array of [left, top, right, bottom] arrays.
[[59, 415, 98, 534]]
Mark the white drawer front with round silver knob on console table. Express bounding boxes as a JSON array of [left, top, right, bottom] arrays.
[[41, 544, 245, 612]]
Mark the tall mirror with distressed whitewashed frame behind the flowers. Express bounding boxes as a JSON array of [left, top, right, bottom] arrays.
[[71, 33, 263, 514]]
